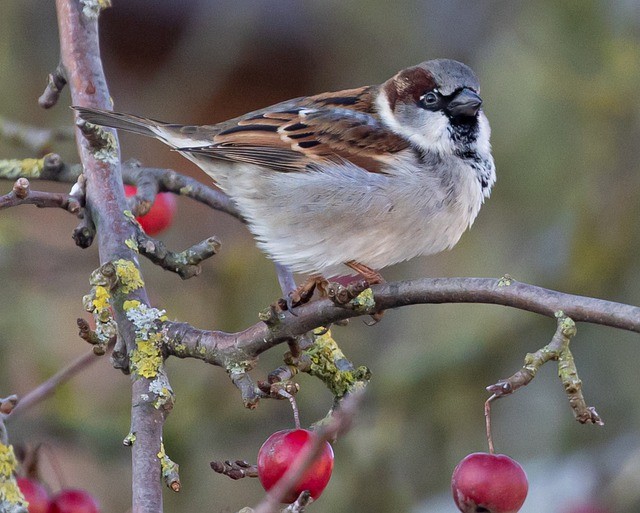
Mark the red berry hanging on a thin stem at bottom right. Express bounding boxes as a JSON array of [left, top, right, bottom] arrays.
[[451, 452, 529, 513]]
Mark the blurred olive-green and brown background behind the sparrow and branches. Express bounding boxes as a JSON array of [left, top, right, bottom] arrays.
[[0, 0, 640, 513]]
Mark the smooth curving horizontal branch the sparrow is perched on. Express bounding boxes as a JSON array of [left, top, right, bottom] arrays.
[[165, 278, 640, 367]]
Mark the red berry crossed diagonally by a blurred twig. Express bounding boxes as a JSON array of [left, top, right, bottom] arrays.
[[258, 429, 333, 503]]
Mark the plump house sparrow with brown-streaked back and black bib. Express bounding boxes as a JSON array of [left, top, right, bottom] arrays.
[[74, 59, 495, 288]]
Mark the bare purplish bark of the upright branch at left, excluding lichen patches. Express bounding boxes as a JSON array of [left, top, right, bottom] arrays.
[[56, 0, 167, 513]]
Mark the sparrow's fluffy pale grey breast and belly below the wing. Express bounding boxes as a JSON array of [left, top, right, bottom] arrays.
[[194, 155, 482, 276]]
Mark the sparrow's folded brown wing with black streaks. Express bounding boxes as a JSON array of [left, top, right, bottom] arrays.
[[179, 87, 409, 172]]
